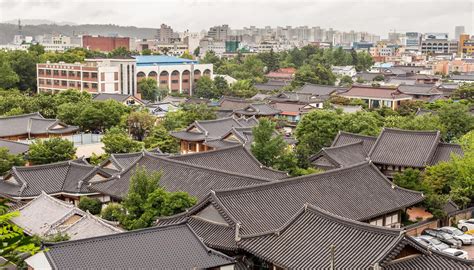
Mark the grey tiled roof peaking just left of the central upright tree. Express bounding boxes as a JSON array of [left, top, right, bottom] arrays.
[[169, 145, 288, 180]]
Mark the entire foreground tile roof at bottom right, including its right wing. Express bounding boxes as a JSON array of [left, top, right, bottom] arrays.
[[238, 205, 473, 269]]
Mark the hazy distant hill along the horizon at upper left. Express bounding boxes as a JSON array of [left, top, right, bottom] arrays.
[[0, 21, 157, 44]]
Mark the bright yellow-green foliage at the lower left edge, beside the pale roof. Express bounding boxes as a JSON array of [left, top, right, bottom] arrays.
[[0, 201, 40, 267]]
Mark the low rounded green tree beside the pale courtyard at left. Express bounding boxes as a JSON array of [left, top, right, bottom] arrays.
[[28, 138, 76, 165]]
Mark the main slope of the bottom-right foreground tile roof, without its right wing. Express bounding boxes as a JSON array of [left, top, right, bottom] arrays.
[[238, 206, 400, 269]]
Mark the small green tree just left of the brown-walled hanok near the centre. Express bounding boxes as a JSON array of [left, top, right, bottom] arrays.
[[144, 124, 180, 153]]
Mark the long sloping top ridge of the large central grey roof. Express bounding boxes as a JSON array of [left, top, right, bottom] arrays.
[[215, 161, 372, 194]]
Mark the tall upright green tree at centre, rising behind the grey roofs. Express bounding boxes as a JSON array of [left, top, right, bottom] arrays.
[[251, 118, 287, 167]]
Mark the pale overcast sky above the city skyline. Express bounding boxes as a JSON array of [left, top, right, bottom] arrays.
[[0, 0, 474, 37]]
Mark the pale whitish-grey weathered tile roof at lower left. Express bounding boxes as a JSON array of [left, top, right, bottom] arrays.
[[12, 192, 122, 240]]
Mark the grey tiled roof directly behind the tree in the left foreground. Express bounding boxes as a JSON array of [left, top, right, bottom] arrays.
[[89, 152, 270, 199]]
